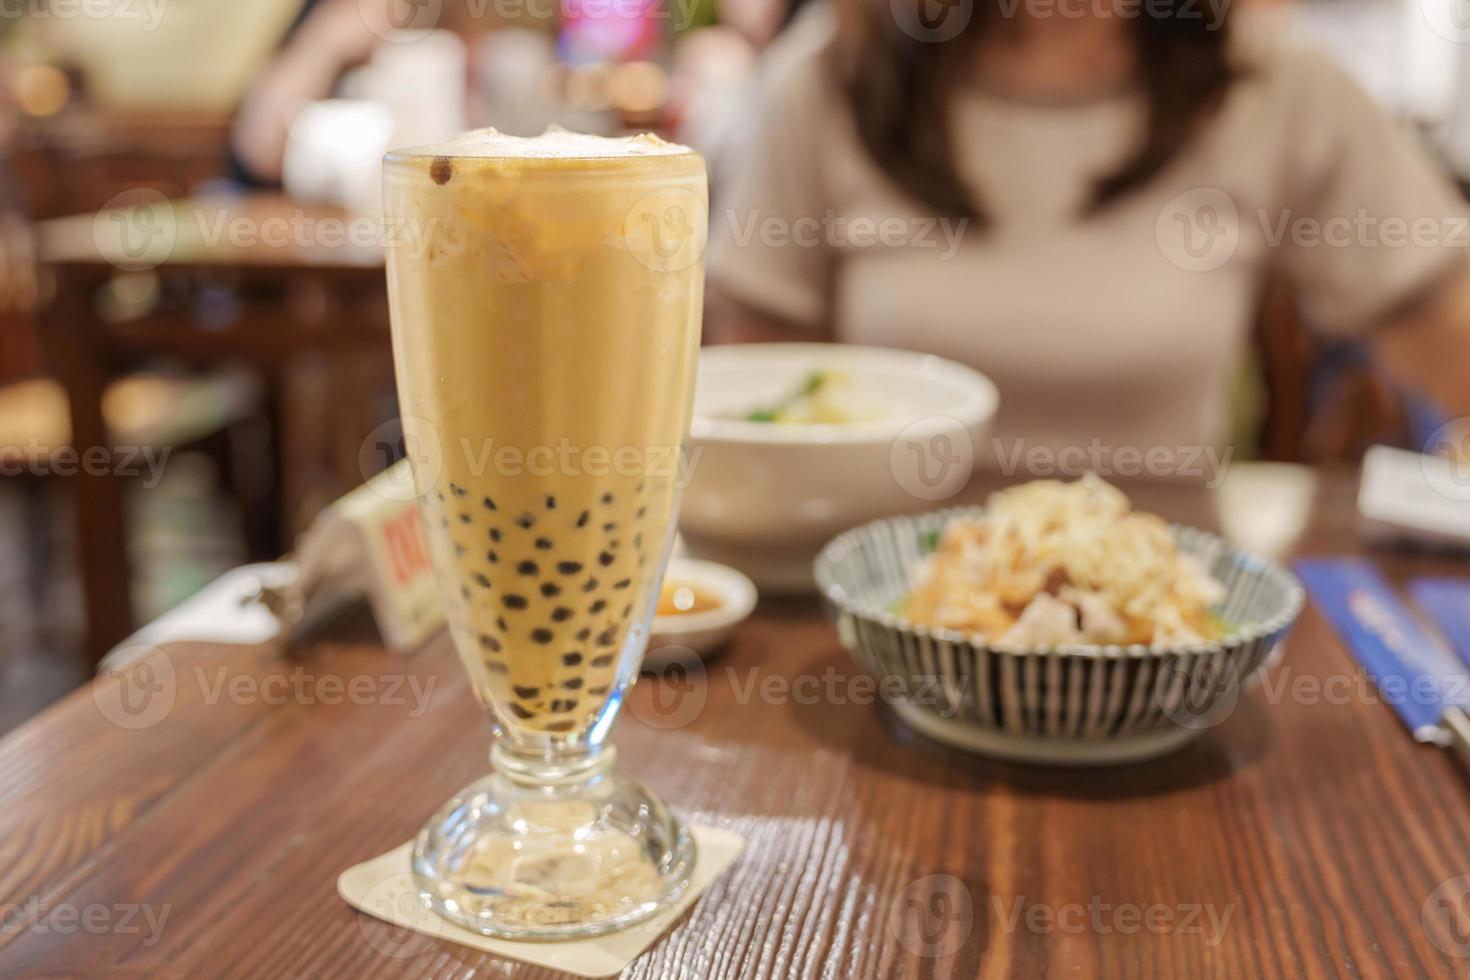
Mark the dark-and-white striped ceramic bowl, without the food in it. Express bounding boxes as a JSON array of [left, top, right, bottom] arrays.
[[816, 508, 1304, 765]]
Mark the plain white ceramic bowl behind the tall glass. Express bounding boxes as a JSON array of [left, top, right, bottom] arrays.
[[679, 344, 1000, 592]]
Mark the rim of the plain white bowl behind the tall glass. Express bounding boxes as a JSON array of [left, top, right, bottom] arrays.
[[689, 342, 1001, 447]]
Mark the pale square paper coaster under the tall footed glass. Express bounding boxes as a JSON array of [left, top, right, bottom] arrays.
[[337, 824, 745, 977]]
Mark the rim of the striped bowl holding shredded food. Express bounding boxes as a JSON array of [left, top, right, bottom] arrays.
[[813, 505, 1307, 660]]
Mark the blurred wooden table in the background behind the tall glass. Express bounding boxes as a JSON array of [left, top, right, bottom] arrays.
[[37, 191, 391, 658]]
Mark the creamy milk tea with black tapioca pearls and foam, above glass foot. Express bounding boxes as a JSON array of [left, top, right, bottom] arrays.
[[385, 131, 707, 733]]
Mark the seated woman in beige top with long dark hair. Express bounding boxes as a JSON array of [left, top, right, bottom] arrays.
[[710, 0, 1470, 458]]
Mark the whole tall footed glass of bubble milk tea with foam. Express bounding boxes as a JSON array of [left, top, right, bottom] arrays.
[[384, 131, 709, 939]]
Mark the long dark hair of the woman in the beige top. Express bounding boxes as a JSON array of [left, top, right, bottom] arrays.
[[838, 0, 1233, 223]]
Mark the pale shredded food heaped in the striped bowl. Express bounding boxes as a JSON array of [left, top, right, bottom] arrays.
[[901, 473, 1229, 649]]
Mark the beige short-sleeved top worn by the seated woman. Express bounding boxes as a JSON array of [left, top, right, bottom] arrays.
[[710, 11, 1470, 475]]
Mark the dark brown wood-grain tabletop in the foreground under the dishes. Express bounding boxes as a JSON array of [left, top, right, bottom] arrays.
[[0, 480, 1470, 980]]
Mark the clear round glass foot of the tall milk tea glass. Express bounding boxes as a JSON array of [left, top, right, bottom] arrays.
[[413, 745, 695, 940]]
